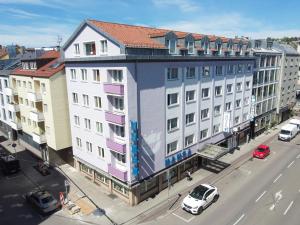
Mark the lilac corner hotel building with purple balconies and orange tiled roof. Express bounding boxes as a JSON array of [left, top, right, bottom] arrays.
[[64, 20, 254, 205]]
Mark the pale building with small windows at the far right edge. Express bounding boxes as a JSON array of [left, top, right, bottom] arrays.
[[274, 43, 300, 122]]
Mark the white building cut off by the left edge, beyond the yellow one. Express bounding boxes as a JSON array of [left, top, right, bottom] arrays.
[[0, 58, 20, 137]]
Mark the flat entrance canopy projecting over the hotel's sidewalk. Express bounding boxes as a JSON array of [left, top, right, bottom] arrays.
[[196, 144, 229, 160]]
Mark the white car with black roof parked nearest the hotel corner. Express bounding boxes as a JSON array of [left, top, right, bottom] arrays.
[[181, 184, 219, 214]]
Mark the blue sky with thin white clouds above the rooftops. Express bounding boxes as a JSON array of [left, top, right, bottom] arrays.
[[0, 0, 300, 47]]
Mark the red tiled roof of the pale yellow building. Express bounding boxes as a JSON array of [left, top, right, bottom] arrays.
[[12, 51, 65, 78]]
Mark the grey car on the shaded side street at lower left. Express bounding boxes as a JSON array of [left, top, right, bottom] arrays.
[[25, 190, 61, 214]]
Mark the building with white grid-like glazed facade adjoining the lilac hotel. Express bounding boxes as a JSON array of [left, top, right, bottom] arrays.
[[250, 39, 282, 137]]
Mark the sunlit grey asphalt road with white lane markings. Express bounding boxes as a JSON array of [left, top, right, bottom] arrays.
[[140, 135, 300, 225]]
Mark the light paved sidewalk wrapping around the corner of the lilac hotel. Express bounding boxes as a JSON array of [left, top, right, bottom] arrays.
[[1, 118, 287, 225]]
